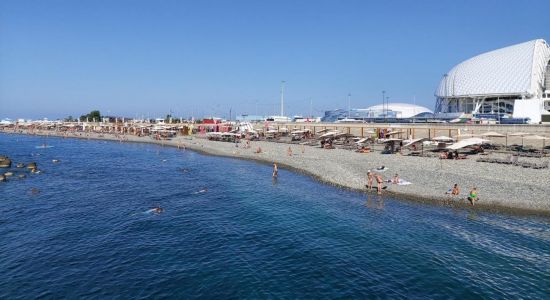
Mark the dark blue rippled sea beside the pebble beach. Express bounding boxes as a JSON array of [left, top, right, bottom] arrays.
[[0, 134, 550, 299]]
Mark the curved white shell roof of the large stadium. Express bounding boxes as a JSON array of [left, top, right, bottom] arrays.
[[435, 39, 550, 98]]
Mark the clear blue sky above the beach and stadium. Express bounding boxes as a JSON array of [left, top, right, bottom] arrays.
[[0, 0, 550, 119]]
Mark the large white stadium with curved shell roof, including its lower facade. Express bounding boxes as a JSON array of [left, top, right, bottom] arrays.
[[435, 39, 550, 123]]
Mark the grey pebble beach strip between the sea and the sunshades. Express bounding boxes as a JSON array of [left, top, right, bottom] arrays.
[[4, 131, 550, 217]]
